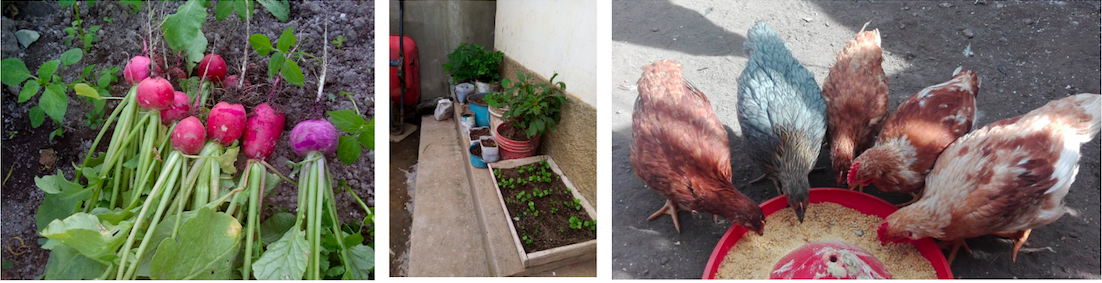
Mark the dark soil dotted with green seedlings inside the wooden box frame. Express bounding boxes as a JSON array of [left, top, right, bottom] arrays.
[[494, 159, 597, 252]]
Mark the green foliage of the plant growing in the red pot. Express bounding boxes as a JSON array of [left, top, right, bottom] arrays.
[[501, 72, 566, 138]]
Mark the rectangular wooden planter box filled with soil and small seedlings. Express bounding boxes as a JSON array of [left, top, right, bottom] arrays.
[[490, 155, 596, 268]]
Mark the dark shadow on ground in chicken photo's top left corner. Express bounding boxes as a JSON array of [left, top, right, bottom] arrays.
[[612, 0, 746, 57]]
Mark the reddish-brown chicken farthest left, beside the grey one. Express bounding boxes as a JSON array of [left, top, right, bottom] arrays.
[[631, 61, 765, 235]]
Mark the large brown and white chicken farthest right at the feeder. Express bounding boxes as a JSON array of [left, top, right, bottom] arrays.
[[878, 94, 1102, 261]]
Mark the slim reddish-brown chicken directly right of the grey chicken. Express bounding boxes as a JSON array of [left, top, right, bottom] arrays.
[[823, 23, 888, 186]]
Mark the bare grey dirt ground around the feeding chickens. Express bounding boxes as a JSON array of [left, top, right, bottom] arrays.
[[606, 0, 1102, 279]]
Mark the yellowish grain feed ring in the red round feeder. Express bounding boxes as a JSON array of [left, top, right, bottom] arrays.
[[715, 203, 937, 279]]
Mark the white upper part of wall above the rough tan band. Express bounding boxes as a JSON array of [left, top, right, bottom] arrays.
[[494, 0, 597, 107]]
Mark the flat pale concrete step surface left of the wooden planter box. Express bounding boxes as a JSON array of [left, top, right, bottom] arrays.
[[409, 116, 493, 276]]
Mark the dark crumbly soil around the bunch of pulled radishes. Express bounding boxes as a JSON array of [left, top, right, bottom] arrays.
[[2, 1, 375, 279]]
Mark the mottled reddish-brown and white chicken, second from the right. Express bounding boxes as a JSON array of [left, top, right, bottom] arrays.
[[847, 67, 980, 202]]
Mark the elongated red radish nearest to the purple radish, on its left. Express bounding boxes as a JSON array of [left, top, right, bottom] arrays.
[[242, 104, 283, 160]]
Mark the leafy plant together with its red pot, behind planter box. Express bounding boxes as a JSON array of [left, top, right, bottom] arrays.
[[491, 72, 566, 160]]
